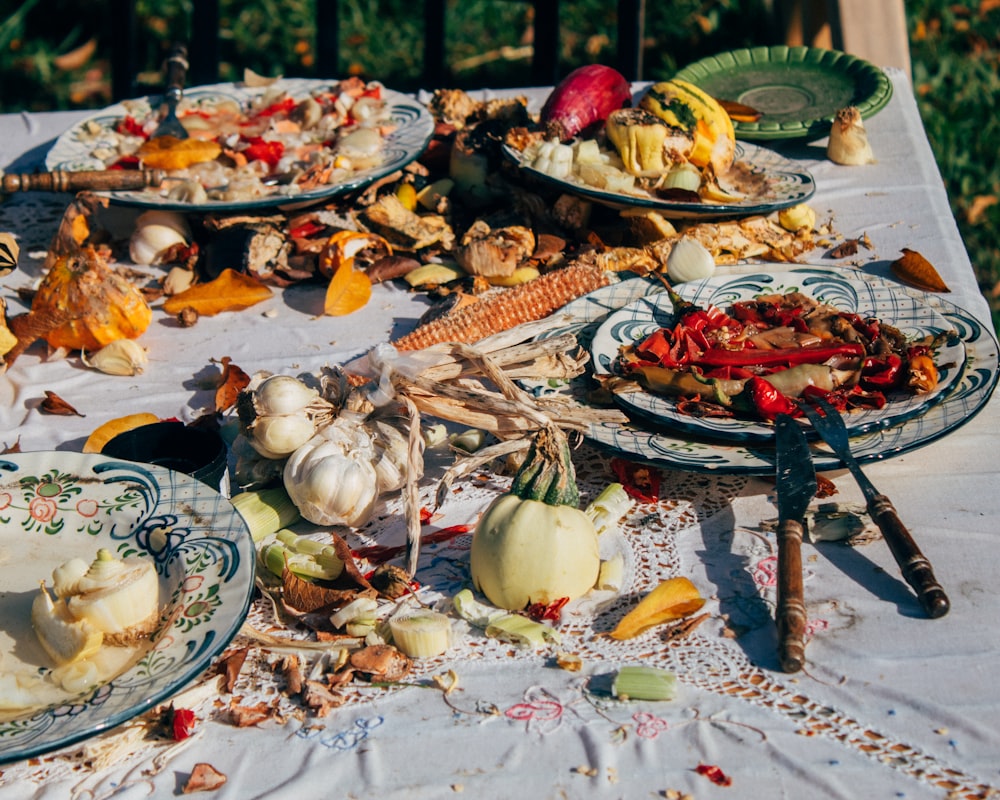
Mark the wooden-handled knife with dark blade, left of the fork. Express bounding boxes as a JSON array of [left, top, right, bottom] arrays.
[[775, 414, 816, 672]]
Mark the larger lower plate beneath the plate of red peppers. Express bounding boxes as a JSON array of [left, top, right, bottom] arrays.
[[530, 264, 1000, 475]]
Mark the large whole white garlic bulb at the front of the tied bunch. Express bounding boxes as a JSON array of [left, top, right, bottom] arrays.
[[283, 418, 378, 528]]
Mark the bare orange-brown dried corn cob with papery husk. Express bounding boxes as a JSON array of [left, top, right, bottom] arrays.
[[393, 264, 613, 350]]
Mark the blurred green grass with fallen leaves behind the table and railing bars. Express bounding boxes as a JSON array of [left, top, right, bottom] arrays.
[[0, 0, 1000, 329]]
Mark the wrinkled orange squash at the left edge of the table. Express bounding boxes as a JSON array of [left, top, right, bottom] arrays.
[[31, 247, 153, 350]]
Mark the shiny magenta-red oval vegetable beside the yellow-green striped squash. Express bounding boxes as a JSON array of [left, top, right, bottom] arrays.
[[540, 64, 632, 142]]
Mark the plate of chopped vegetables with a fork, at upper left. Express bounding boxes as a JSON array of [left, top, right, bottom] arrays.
[[45, 78, 434, 212]]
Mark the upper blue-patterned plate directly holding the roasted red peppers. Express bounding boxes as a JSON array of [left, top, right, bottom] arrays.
[[591, 270, 965, 443]]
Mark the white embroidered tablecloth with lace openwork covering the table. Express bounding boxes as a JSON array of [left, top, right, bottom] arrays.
[[0, 71, 1000, 800]]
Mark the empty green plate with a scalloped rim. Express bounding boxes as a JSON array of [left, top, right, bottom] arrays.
[[676, 46, 892, 139]]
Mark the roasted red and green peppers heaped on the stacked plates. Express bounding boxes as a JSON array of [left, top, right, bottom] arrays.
[[616, 292, 938, 420]]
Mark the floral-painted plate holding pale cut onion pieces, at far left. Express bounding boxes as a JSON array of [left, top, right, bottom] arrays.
[[0, 452, 254, 763]]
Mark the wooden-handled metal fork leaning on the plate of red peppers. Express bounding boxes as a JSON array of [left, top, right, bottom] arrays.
[[800, 398, 951, 619]]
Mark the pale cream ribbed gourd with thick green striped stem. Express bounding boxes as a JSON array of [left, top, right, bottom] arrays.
[[470, 427, 601, 610]]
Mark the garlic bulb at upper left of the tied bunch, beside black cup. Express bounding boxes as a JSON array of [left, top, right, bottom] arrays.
[[236, 373, 334, 459]]
